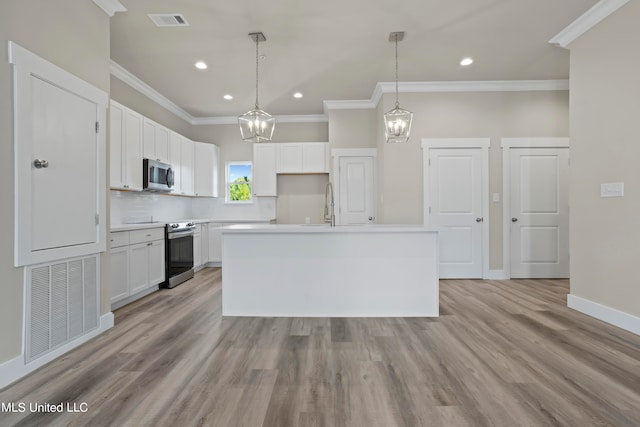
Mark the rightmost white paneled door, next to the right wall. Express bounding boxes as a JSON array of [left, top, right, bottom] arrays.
[[508, 148, 569, 278]]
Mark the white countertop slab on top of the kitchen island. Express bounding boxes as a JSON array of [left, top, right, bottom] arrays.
[[222, 224, 440, 233]]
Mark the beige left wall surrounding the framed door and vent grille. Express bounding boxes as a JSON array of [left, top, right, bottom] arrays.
[[0, 0, 110, 363]]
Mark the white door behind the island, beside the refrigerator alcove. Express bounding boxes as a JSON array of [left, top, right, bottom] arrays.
[[336, 157, 375, 225]]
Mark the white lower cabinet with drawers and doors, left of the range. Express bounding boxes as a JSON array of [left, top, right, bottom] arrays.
[[110, 228, 165, 309]]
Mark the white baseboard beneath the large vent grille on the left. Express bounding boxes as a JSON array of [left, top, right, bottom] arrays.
[[0, 312, 114, 389]]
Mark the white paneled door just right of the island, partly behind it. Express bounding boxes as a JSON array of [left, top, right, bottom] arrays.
[[427, 148, 485, 278]]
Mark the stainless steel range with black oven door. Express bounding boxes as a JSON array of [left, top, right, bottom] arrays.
[[163, 222, 196, 288]]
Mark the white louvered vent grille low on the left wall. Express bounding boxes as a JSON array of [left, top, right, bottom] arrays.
[[25, 255, 99, 362]]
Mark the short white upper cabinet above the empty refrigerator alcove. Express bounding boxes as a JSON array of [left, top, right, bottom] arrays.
[[276, 142, 329, 173]]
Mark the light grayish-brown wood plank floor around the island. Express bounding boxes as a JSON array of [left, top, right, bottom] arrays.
[[0, 269, 640, 427]]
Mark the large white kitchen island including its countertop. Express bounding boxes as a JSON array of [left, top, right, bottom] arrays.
[[222, 224, 439, 317]]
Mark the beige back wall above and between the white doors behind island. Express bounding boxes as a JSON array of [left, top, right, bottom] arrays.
[[329, 91, 569, 269]]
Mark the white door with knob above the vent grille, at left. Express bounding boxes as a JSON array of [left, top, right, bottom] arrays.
[[31, 78, 98, 251]]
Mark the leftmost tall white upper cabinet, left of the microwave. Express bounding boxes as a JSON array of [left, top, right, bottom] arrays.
[[109, 101, 144, 191]]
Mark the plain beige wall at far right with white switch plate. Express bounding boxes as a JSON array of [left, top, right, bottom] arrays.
[[570, 1, 640, 316]]
